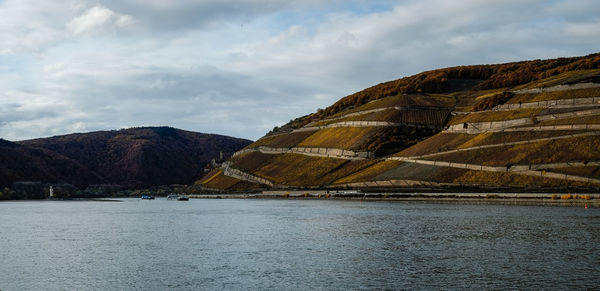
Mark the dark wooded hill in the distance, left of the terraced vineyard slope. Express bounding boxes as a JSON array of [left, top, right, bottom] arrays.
[[7, 127, 251, 188]]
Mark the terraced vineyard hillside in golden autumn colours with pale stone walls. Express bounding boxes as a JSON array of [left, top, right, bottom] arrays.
[[197, 54, 600, 191]]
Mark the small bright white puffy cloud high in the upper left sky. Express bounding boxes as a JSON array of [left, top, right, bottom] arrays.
[[67, 5, 133, 35]]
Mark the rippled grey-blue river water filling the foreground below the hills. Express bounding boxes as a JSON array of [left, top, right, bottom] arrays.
[[0, 199, 600, 291]]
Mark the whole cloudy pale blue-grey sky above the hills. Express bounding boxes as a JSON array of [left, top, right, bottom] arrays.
[[0, 0, 600, 141]]
